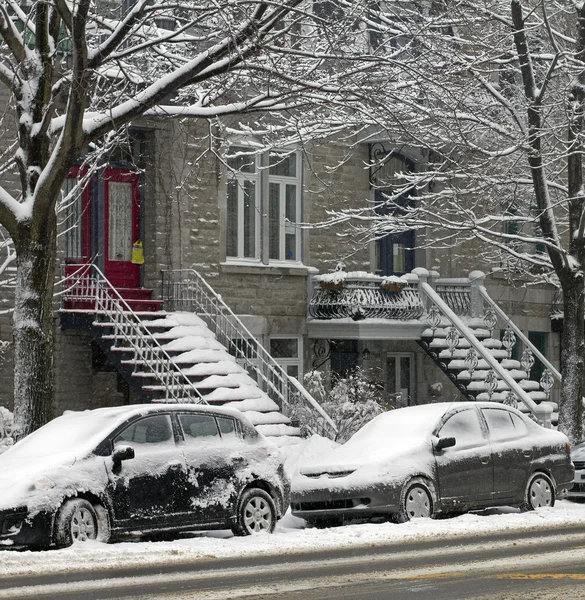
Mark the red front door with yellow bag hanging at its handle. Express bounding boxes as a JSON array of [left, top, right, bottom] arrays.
[[104, 169, 140, 289]]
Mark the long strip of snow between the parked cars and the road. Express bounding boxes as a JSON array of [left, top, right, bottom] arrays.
[[0, 500, 585, 576]]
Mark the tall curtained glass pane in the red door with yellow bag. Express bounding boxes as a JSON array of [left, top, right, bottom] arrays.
[[108, 181, 132, 261]]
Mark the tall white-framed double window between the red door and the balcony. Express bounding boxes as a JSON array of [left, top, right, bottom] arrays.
[[226, 146, 301, 263]]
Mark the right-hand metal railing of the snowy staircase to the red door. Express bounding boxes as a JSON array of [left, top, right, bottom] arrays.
[[162, 269, 337, 437]]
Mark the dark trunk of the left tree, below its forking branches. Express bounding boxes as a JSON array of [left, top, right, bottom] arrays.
[[13, 211, 56, 440]]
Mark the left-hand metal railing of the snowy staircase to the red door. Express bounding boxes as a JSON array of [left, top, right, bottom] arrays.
[[62, 264, 207, 404]]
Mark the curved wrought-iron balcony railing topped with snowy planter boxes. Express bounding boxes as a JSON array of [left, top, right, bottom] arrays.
[[309, 272, 424, 321]]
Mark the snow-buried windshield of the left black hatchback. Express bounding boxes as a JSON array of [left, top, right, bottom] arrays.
[[6, 410, 126, 459]]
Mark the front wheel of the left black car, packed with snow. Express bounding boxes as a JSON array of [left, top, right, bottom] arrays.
[[54, 498, 109, 548]]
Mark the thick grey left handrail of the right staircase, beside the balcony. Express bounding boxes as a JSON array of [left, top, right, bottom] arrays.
[[420, 282, 552, 427]]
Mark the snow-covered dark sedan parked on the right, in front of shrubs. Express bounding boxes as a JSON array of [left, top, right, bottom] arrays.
[[291, 402, 573, 525]]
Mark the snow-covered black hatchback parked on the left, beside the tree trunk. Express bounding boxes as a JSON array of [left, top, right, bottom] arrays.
[[0, 404, 290, 547]]
